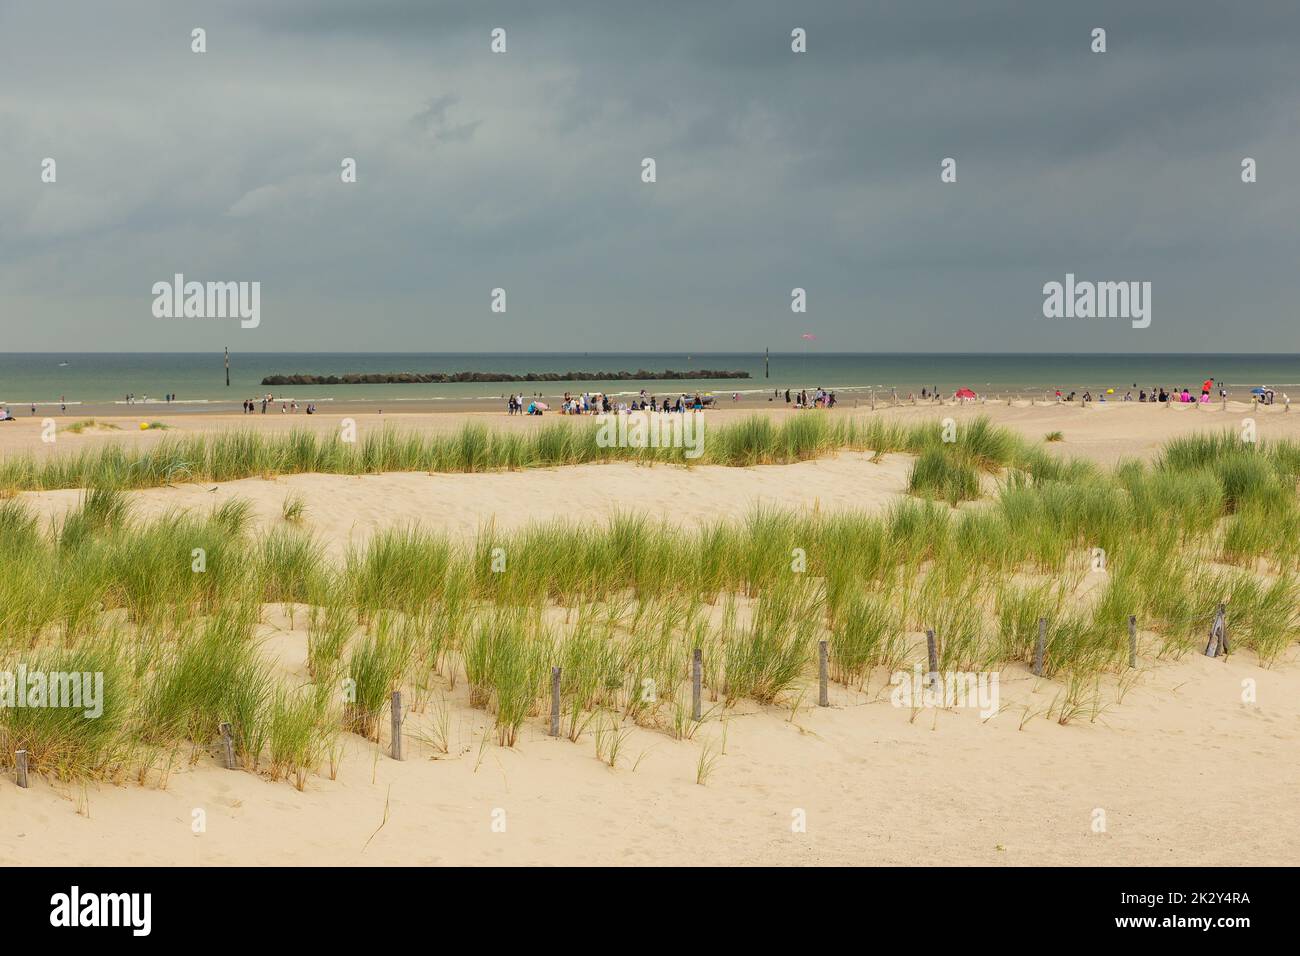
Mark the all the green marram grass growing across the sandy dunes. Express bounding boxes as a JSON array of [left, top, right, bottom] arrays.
[[0, 416, 1300, 787]]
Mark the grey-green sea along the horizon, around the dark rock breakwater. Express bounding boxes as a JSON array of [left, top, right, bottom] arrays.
[[0, 347, 1300, 411]]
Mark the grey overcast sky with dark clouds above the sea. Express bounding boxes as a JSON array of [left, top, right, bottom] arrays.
[[0, 0, 1300, 352]]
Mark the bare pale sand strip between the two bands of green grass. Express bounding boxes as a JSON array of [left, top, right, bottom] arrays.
[[22, 453, 911, 554]]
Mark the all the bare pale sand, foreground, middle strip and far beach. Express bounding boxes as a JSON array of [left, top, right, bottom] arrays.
[[0, 403, 1300, 866]]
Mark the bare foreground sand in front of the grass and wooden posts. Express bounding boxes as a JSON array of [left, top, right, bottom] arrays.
[[0, 618, 1300, 866]]
